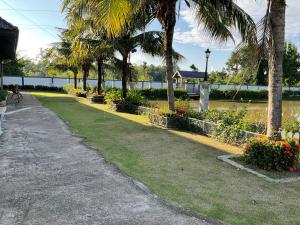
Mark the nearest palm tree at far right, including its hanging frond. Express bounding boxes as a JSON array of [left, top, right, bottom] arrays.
[[256, 0, 286, 139]]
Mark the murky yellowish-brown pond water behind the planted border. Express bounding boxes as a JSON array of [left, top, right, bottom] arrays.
[[151, 100, 300, 122]]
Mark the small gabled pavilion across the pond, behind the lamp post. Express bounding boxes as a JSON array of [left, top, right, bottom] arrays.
[[173, 70, 205, 87]]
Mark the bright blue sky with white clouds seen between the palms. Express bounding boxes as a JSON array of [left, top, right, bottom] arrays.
[[0, 0, 300, 70]]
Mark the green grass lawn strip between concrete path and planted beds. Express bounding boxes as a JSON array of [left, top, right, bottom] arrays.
[[33, 93, 300, 225]]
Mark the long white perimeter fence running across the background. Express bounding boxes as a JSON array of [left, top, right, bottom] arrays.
[[3, 76, 300, 94]]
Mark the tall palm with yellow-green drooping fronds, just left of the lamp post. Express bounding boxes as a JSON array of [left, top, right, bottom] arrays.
[[72, 0, 255, 110]]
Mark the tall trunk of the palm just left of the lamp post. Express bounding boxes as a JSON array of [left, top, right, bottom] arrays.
[[164, 0, 176, 111]]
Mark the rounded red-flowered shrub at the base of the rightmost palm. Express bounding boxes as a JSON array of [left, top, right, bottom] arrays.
[[243, 136, 300, 172]]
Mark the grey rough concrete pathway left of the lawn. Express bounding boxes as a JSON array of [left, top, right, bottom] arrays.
[[0, 95, 216, 225]]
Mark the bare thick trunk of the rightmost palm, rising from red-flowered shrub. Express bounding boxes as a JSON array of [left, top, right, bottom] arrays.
[[267, 0, 286, 139]]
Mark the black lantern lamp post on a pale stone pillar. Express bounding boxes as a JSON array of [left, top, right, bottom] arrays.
[[199, 49, 211, 112]]
